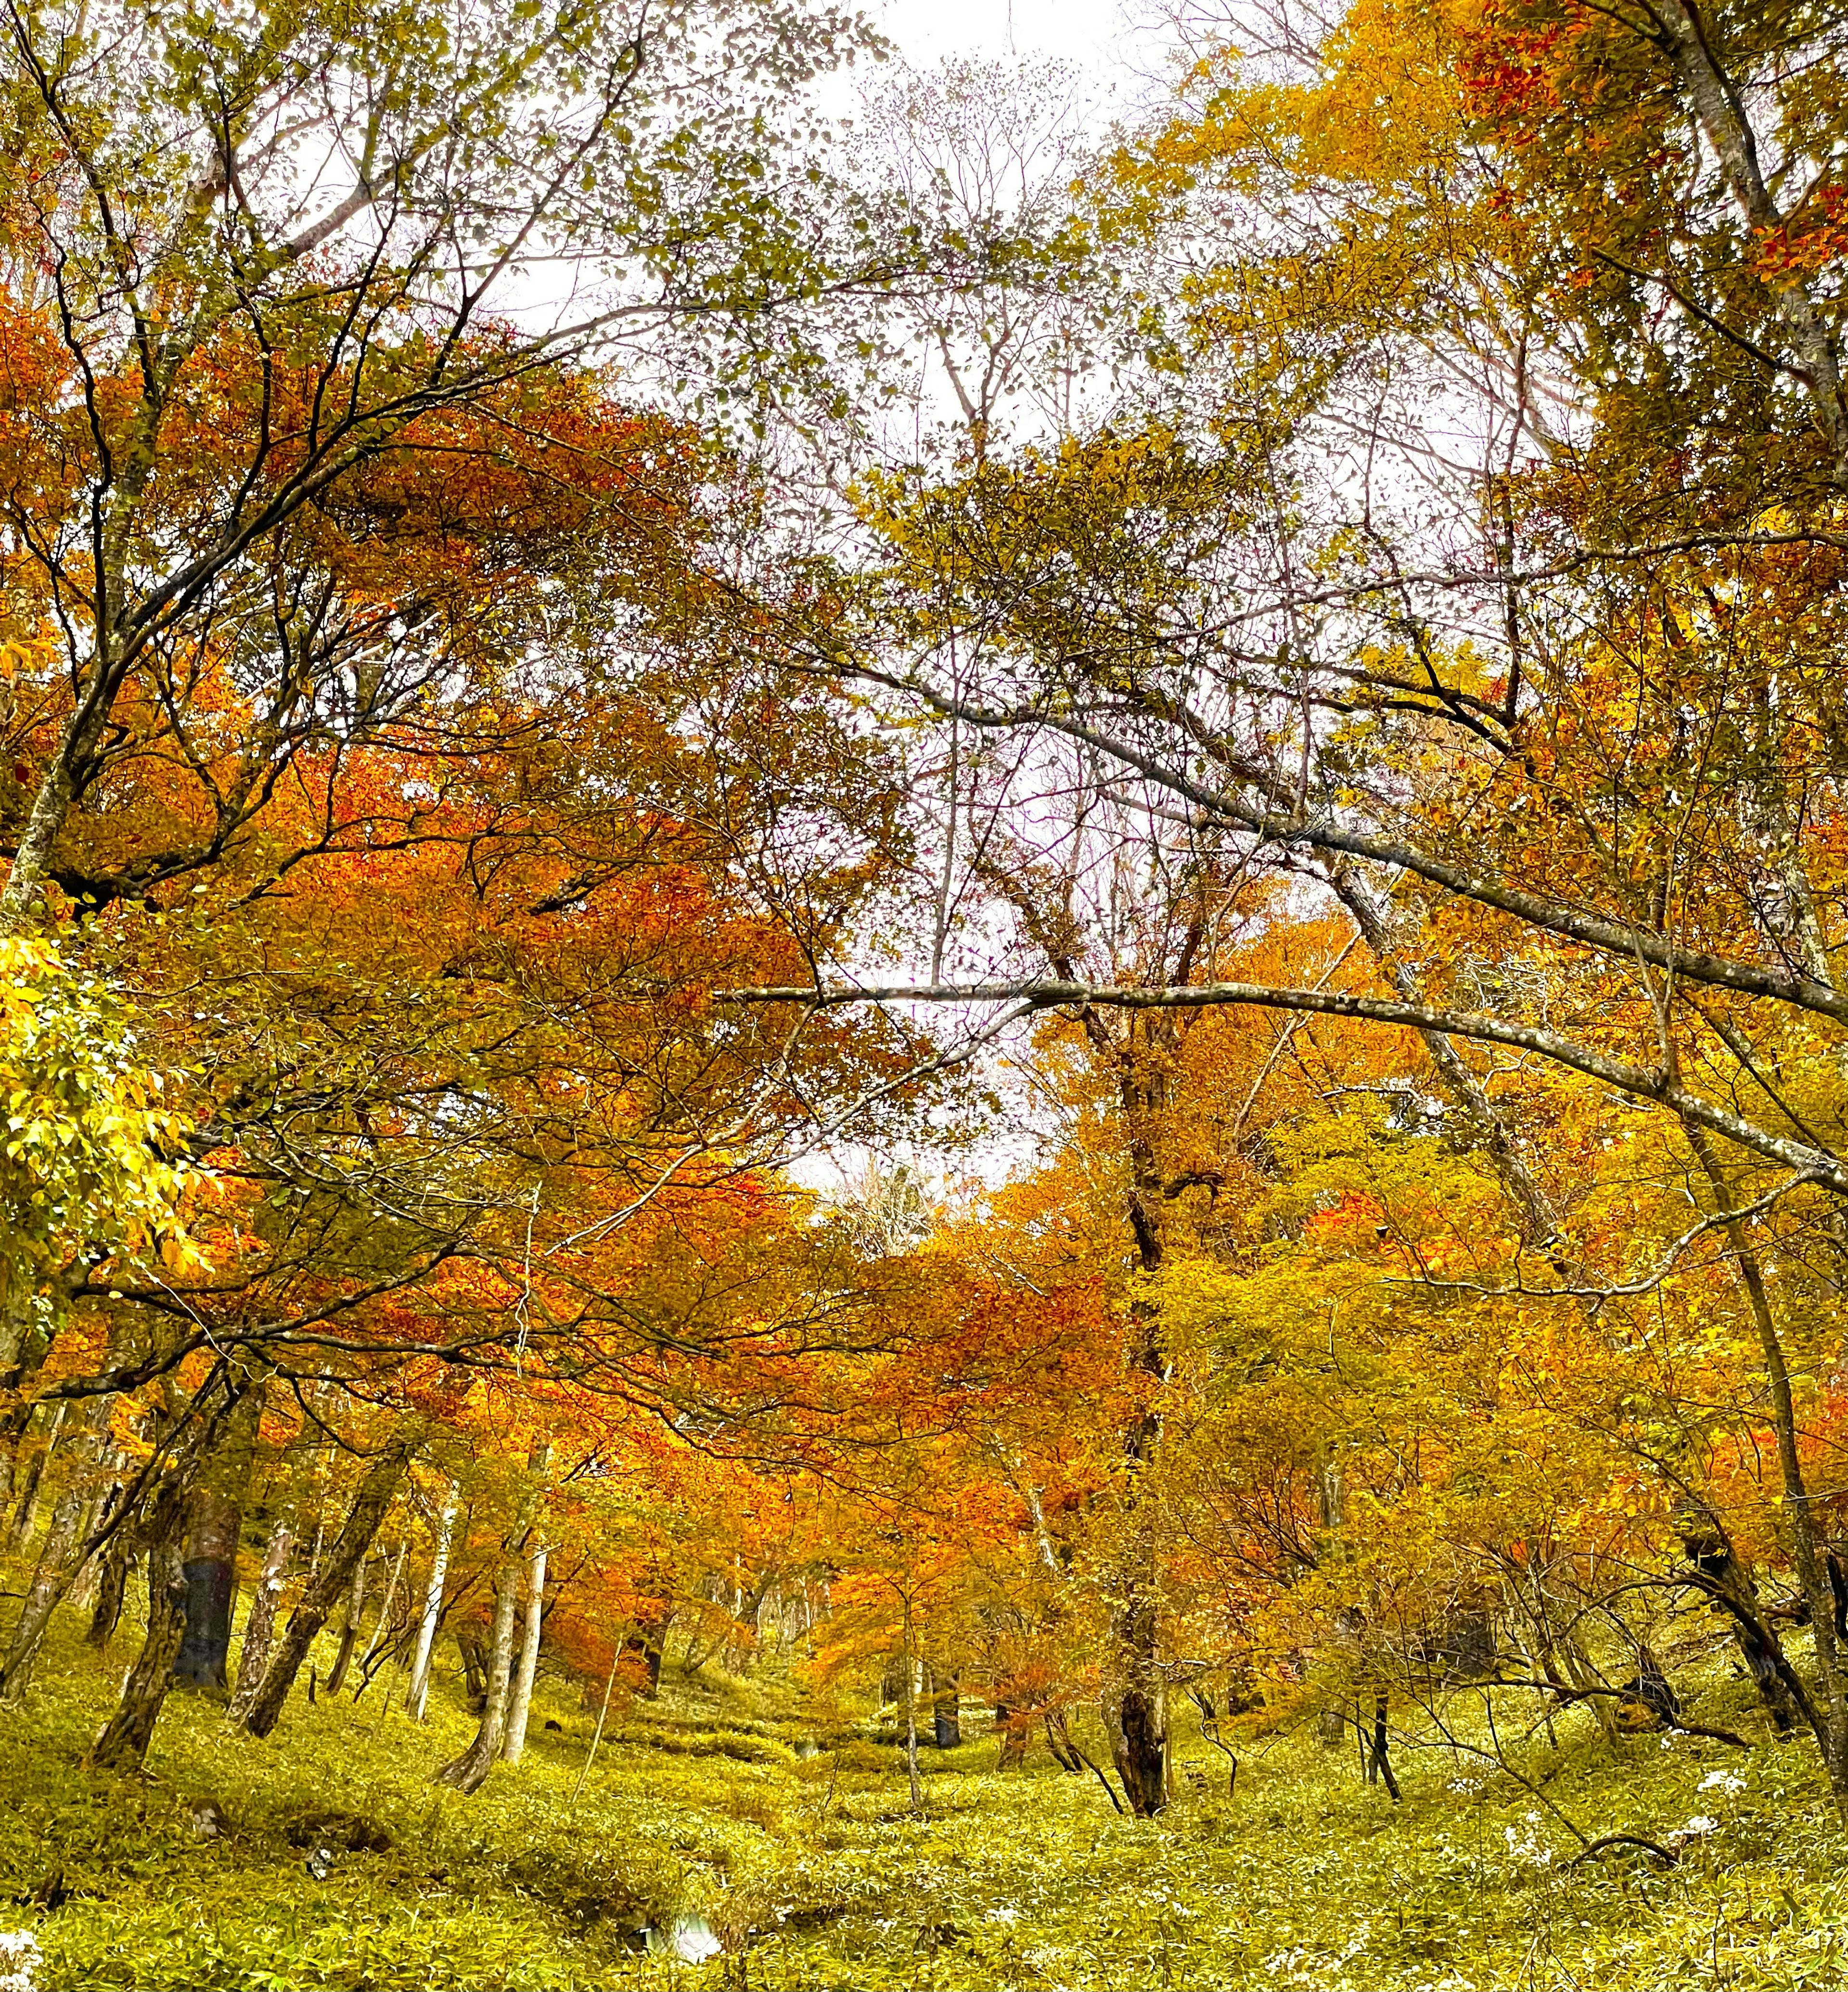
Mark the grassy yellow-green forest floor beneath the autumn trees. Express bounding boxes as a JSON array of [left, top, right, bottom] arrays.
[[0, 1616, 1848, 1992]]
